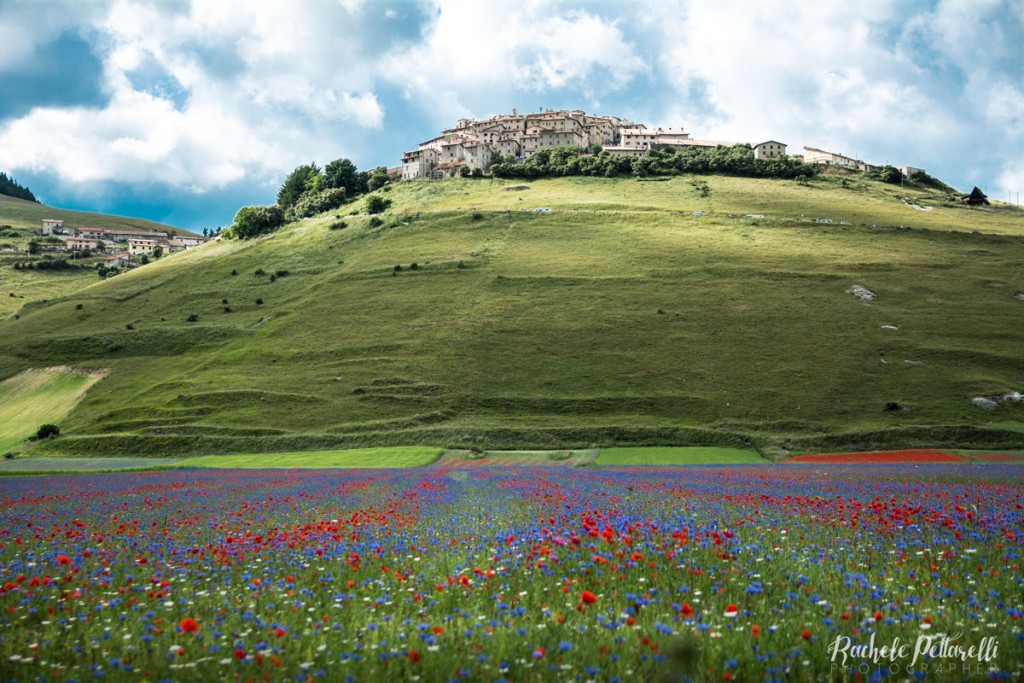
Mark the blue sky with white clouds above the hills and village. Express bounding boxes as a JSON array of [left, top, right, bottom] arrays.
[[0, 0, 1024, 230]]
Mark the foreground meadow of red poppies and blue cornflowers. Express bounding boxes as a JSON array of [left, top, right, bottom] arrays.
[[0, 463, 1024, 682]]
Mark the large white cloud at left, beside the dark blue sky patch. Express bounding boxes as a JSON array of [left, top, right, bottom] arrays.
[[0, 0, 384, 191]]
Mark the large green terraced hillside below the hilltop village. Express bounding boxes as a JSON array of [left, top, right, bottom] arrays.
[[0, 177, 1024, 455]]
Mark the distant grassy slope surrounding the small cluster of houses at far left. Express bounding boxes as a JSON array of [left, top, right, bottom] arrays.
[[0, 195, 190, 319]]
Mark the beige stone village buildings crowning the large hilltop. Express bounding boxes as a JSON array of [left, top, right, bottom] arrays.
[[401, 110, 923, 180]]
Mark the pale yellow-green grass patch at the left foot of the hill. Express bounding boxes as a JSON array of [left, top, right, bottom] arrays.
[[0, 368, 100, 453]]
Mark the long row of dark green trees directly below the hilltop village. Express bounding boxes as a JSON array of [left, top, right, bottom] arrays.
[[490, 144, 818, 179]]
